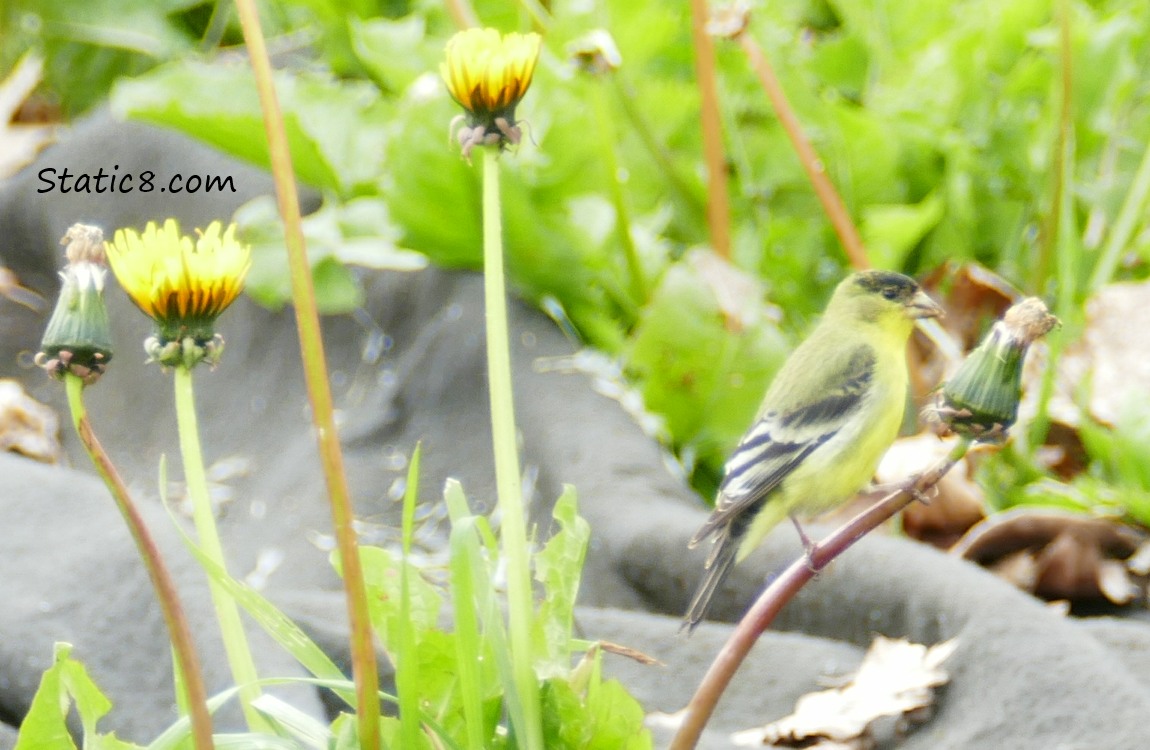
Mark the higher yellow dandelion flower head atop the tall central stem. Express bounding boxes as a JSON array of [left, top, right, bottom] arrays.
[[439, 29, 543, 155]]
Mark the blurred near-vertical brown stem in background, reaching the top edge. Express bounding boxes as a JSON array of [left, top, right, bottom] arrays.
[[691, 0, 730, 259]]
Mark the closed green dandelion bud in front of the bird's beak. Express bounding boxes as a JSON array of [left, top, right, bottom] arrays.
[[936, 297, 1058, 442]]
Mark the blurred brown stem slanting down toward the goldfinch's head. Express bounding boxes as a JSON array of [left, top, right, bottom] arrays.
[[738, 32, 871, 270]]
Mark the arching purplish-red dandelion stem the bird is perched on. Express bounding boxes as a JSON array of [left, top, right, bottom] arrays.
[[669, 441, 969, 750]]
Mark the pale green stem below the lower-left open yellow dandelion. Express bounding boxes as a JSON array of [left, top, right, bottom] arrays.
[[175, 366, 264, 732]]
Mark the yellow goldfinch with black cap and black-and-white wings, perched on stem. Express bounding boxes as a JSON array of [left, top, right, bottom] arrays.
[[683, 270, 942, 632]]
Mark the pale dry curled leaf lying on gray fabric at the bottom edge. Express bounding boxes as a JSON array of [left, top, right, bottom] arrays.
[[733, 636, 958, 749]]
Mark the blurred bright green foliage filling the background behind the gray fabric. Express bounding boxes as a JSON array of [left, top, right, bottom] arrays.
[[0, 0, 1150, 492]]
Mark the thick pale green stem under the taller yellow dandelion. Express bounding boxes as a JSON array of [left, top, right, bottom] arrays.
[[483, 148, 543, 750]]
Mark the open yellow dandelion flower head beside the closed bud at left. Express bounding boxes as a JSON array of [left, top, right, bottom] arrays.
[[105, 219, 252, 365]]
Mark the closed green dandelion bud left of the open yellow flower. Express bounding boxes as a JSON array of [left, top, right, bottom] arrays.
[[36, 224, 112, 383]]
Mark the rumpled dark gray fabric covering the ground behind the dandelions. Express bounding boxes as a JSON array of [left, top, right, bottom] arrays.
[[0, 116, 1150, 750]]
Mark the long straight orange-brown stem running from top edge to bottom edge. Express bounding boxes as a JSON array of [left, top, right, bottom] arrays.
[[236, 0, 381, 750]]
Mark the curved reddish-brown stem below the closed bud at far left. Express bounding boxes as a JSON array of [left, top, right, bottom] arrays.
[[64, 373, 215, 750]]
